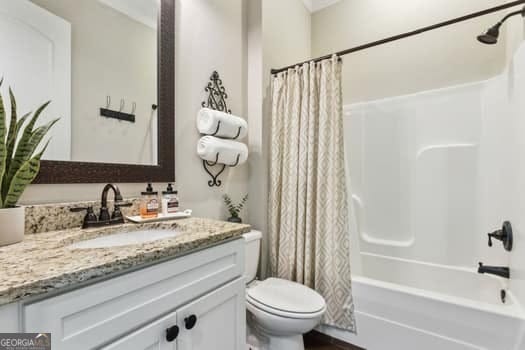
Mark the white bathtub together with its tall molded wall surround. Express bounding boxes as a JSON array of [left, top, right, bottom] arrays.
[[322, 43, 525, 350]]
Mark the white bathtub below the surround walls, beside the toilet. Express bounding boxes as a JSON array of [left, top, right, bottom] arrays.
[[320, 253, 525, 350]]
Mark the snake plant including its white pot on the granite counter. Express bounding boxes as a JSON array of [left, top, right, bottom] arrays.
[[0, 79, 58, 246]]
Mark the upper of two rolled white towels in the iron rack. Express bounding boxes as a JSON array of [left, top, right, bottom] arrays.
[[197, 108, 248, 140]]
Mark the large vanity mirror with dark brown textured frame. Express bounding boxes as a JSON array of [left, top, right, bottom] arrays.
[[0, 0, 175, 183]]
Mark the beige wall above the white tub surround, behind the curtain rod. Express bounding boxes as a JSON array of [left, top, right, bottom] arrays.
[[312, 0, 509, 103]]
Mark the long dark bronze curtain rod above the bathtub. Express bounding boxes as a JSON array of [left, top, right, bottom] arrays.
[[271, 0, 525, 74]]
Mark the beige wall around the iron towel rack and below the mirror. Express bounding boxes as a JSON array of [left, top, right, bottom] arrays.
[[21, 0, 247, 218]]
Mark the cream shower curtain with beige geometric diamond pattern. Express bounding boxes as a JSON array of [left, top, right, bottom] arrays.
[[268, 56, 355, 332]]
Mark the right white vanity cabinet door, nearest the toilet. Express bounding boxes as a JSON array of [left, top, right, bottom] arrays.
[[177, 278, 246, 350]]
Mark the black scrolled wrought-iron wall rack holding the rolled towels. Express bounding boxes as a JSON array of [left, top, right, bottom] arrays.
[[201, 71, 241, 187]]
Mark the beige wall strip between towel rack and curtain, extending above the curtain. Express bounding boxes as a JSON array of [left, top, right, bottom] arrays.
[[247, 0, 311, 275]]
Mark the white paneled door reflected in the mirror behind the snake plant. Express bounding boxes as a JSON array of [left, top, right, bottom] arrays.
[[0, 0, 71, 160]]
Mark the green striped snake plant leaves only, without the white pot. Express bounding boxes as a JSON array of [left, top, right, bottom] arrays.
[[0, 79, 58, 208]]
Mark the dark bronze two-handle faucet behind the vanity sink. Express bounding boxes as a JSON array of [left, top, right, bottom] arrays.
[[70, 184, 132, 228]]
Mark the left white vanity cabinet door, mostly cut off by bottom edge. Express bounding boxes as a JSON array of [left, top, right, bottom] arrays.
[[101, 312, 179, 350]]
